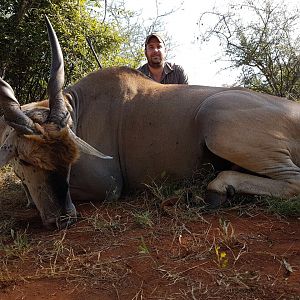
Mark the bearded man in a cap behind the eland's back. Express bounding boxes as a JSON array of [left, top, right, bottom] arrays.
[[138, 33, 188, 84]]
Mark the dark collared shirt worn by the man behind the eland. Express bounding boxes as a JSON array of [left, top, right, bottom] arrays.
[[138, 62, 188, 84]]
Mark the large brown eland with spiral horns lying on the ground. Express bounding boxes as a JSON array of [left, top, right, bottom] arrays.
[[0, 18, 300, 228]]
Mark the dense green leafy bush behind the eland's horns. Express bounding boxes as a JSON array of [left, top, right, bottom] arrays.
[[0, 0, 144, 104]]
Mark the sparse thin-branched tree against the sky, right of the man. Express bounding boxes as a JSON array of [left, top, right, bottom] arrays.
[[199, 0, 300, 100]]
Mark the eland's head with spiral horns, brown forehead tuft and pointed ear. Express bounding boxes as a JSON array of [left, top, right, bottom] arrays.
[[0, 17, 111, 228]]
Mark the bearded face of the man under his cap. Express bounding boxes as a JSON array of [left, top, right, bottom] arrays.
[[145, 37, 166, 68]]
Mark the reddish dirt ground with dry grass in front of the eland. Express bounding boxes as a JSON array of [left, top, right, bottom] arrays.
[[0, 166, 300, 300]]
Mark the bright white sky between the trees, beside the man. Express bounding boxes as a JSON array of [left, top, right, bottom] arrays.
[[126, 0, 299, 86]]
